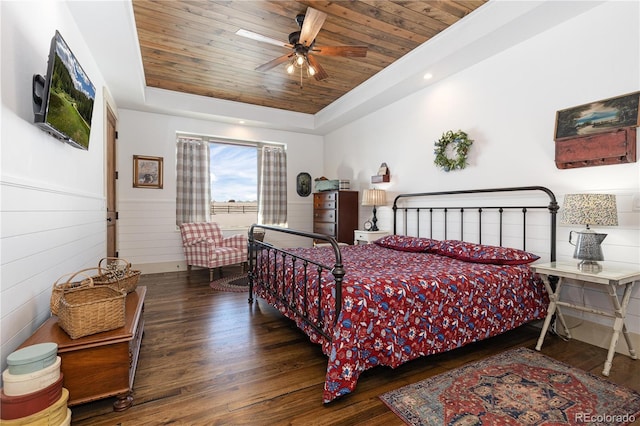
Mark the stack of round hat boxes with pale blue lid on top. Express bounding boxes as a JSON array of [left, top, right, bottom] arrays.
[[0, 343, 71, 426]]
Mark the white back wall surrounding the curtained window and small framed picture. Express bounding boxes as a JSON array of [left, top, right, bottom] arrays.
[[117, 109, 323, 272]]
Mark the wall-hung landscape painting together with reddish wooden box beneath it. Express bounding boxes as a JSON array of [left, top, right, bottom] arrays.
[[554, 92, 640, 169]]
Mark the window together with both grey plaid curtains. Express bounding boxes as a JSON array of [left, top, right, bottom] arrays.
[[176, 136, 287, 228]]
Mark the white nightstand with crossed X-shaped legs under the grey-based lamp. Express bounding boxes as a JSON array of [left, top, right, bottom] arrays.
[[531, 262, 640, 376]]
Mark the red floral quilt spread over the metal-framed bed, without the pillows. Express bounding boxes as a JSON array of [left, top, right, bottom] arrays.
[[254, 244, 548, 403]]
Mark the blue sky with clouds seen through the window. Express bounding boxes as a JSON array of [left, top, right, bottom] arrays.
[[209, 143, 258, 202]]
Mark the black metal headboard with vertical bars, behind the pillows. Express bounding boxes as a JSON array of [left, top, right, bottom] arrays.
[[393, 186, 559, 262]]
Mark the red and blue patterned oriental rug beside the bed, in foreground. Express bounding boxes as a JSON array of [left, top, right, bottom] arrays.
[[380, 348, 640, 426]]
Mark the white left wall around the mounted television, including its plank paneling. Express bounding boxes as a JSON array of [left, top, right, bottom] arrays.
[[0, 1, 106, 369]]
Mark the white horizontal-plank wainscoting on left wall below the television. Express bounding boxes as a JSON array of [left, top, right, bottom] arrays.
[[0, 176, 106, 369]]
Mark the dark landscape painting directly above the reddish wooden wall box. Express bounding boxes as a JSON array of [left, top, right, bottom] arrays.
[[554, 92, 640, 140]]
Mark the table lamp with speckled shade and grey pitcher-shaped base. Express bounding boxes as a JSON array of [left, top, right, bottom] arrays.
[[560, 194, 618, 272]]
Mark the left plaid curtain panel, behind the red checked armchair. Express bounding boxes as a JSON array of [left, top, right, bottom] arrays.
[[176, 138, 211, 226]]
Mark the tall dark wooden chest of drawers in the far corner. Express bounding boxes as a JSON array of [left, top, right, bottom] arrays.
[[313, 191, 358, 244]]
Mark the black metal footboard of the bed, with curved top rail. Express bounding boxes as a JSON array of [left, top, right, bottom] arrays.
[[248, 224, 345, 341]]
